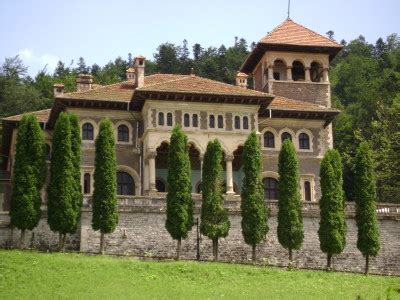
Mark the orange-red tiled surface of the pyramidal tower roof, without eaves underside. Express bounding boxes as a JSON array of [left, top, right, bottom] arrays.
[[260, 19, 342, 48]]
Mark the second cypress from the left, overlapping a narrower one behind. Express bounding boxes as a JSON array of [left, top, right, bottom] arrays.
[[47, 113, 79, 251]]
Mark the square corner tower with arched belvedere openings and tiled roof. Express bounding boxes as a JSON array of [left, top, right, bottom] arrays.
[[241, 19, 342, 107]]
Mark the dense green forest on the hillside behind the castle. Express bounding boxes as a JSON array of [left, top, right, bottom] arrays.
[[0, 31, 400, 203]]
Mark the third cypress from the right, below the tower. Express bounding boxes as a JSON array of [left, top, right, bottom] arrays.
[[277, 139, 304, 264]]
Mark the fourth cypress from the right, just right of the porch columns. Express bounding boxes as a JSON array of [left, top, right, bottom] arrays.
[[241, 131, 268, 261]]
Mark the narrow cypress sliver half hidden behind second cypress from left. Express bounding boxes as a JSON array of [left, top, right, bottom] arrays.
[[69, 114, 83, 233]]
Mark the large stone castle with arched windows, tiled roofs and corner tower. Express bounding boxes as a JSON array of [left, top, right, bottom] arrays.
[[0, 19, 400, 274]]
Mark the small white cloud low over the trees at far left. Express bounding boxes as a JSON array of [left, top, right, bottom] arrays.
[[18, 49, 60, 76]]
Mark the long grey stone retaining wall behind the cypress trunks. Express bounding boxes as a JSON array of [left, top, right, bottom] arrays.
[[0, 198, 400, 275]]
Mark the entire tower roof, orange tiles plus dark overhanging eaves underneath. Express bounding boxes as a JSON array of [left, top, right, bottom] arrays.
[[240, 19, 342, 73]]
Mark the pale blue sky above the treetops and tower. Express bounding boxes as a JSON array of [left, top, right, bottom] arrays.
[[0, 0, 400, 76]]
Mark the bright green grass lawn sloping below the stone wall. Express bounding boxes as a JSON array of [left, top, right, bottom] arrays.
[[0, 250, 400, 299]]
